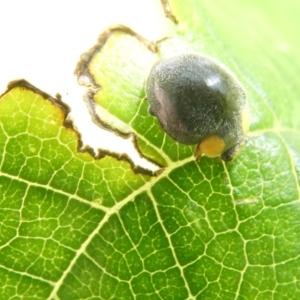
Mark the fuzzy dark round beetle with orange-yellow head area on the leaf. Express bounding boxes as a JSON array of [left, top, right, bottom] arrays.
[[146, 53, 248, 161]]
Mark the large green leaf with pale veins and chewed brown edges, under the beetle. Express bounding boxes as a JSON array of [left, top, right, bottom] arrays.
[[0, 0, 300, 299]]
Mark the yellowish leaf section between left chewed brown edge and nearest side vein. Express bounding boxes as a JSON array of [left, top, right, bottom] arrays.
[[0, 88, 147, 206]]
